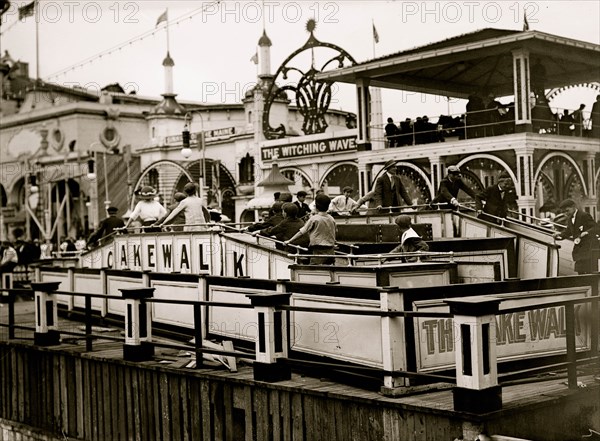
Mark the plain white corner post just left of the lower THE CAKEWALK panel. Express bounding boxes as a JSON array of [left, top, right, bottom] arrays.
[[380, 288, 410, 396]]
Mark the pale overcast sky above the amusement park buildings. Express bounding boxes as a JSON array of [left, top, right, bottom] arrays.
[[0, 0, 600, 120]]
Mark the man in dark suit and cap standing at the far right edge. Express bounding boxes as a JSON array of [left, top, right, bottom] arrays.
[[554, 199, 600, 274]]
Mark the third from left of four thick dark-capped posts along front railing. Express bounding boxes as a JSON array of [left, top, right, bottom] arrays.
[[246, 292, 292, 382]]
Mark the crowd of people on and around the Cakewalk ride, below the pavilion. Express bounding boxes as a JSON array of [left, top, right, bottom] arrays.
[[0, 171, 600, 274]]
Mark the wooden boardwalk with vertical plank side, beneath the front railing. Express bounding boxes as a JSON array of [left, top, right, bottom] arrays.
[[0, 301, 600, 441]]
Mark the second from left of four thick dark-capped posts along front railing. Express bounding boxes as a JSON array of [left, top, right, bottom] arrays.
[[119, 288, 154, 361]]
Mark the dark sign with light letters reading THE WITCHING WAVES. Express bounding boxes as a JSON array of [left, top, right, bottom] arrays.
[[261, 136, 356, 161]]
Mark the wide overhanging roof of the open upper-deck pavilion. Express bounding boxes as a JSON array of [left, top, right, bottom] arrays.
[[317, 28, 600, 98]]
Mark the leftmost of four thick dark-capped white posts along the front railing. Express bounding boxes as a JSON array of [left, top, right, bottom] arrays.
[[31, 282, 61, 346]]
